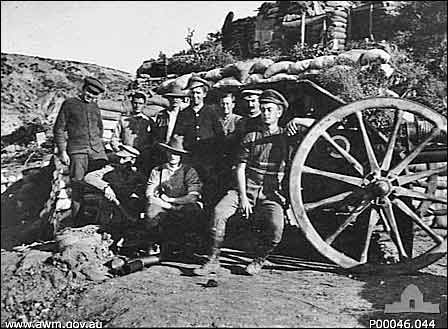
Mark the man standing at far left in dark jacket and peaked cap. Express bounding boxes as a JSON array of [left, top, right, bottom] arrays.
[[53, 77, 107, 215]]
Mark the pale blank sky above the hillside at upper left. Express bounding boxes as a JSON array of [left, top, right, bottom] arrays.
[[1, 1, 263, 74]]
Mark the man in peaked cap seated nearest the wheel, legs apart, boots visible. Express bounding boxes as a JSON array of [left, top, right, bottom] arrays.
[[194, 89, 310, 275]]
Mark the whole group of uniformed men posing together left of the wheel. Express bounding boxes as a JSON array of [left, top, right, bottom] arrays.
[[54, 76, 308, 275]]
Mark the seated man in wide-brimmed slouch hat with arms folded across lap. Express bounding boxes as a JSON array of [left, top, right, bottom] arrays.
[[146, 135, 204, 255]]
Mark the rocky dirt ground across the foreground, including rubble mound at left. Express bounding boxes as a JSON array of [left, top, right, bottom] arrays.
[[1, 169, 447, 328]]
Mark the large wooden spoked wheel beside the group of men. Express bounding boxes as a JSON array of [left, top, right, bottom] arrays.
[[290, 97, 447, 273]]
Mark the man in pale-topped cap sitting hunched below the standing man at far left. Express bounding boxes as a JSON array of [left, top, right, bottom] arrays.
[[84, 145, 145, 219]]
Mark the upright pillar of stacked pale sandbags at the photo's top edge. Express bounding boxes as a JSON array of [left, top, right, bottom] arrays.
[[326, 1, 350, 50]]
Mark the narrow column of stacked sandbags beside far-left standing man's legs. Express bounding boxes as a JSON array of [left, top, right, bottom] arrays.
[[39, 156, 72, 233]]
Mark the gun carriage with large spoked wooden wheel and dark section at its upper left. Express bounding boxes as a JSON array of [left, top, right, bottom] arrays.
[[238, 80, 447, 273]]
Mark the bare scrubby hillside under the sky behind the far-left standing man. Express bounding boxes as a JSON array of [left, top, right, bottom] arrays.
[[1, 53, 132, 136]]
